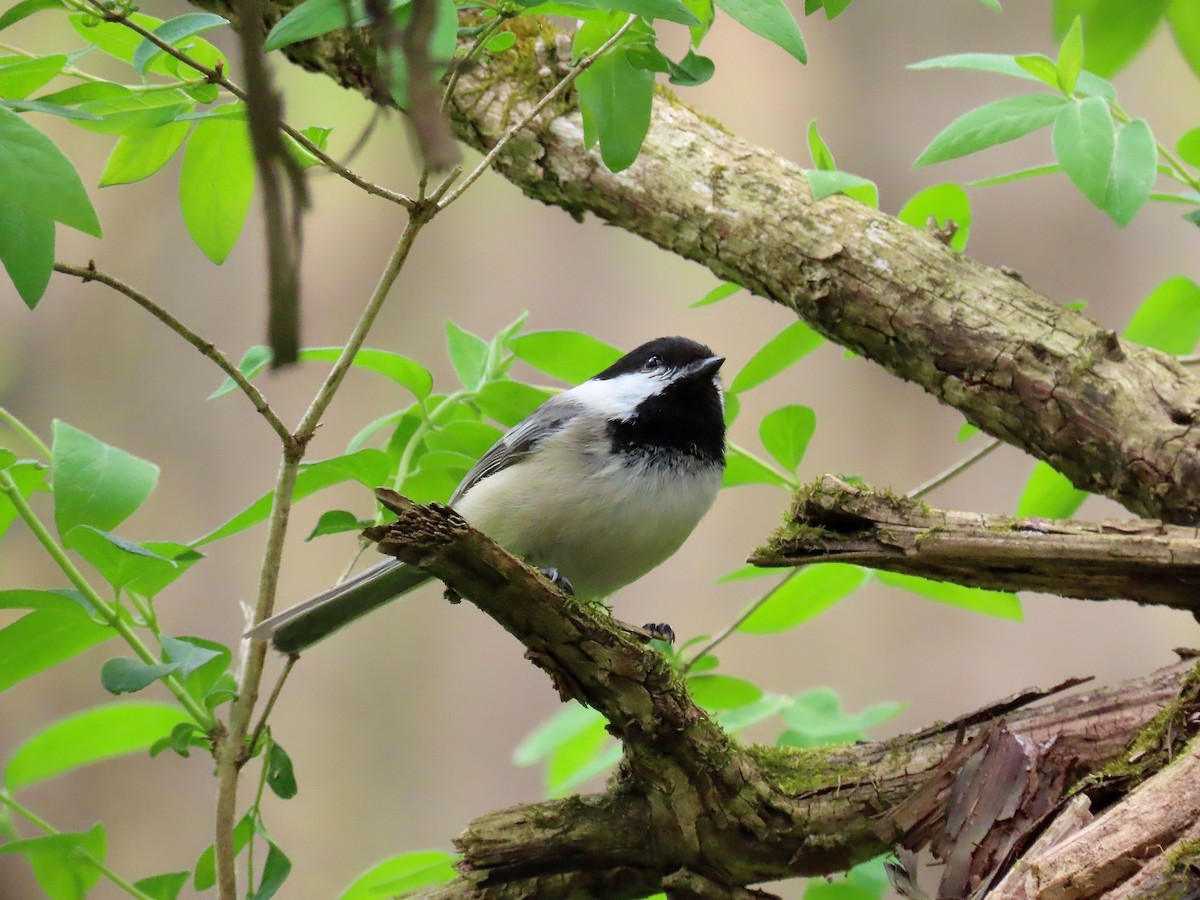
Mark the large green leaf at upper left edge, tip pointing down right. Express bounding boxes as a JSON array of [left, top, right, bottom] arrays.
[[0, 108, 101, 238]]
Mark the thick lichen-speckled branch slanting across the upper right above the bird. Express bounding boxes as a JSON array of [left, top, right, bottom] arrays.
[[171, 0, 1200, 524]]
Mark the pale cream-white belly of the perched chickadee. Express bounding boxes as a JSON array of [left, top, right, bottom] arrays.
[[456, 454, 721, 600]]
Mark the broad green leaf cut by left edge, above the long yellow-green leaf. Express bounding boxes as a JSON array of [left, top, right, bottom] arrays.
[[0, 590, 116, 691]]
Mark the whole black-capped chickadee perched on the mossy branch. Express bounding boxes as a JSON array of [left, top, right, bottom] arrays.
[[247, 337, 725, 654]]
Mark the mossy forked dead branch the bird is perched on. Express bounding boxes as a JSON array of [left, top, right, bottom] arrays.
[[355, 490, 1186, 898]]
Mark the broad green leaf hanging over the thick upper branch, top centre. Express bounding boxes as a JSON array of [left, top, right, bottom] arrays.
[[575, 19, 654, 172]]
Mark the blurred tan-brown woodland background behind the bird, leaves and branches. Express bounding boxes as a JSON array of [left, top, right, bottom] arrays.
[[0, 0, 1200, 900]]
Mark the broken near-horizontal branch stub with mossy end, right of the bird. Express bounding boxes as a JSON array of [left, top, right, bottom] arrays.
[[751, 475, 1200, 613]]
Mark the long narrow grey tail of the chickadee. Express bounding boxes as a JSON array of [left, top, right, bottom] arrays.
[[246, 559, 431, 654]]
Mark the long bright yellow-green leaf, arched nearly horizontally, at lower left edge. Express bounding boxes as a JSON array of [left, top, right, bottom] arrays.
[[4, 701, 187, 791]]
